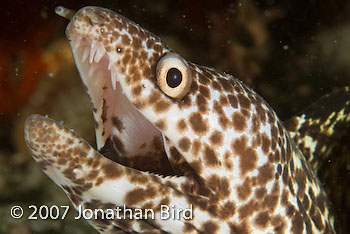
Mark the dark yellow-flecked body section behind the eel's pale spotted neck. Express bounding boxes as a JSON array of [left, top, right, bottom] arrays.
[[284, 86, 350, 233]]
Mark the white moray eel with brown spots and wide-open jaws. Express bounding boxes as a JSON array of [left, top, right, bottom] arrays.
[[25, 7, 344, 234]]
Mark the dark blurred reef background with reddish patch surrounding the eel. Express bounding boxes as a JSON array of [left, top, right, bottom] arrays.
[[0, 0, 350, 234]]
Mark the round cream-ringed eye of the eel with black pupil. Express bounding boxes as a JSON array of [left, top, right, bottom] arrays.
[[157, 54, 192, 99]]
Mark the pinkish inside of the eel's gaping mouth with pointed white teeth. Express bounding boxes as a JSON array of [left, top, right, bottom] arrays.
[[70, 35, 175, 175]]
